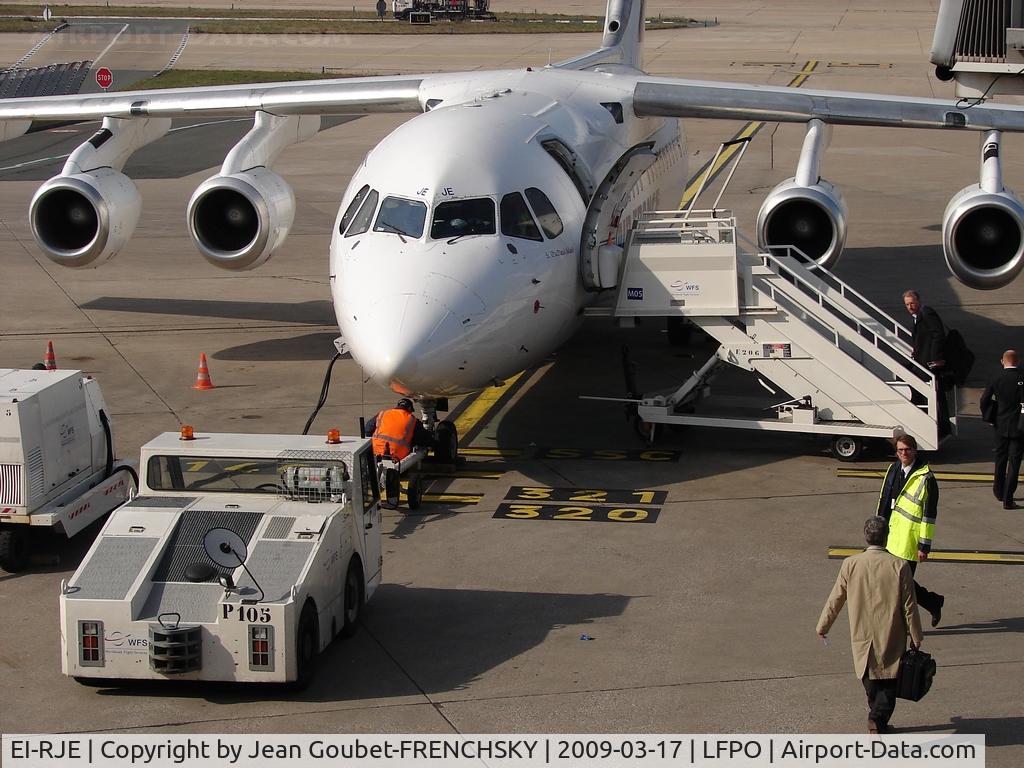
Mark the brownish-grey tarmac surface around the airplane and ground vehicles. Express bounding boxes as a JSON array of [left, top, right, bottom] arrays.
[[0, 0, 1024, 768]]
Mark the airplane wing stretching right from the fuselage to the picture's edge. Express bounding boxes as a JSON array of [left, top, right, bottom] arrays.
[[633, 77, 1024, 131]]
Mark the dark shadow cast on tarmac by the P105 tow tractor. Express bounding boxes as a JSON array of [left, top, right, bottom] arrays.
[[90, 584, 631, 705]]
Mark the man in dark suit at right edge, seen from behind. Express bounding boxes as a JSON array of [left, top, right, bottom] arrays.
[[981, 349, 1024, 509]]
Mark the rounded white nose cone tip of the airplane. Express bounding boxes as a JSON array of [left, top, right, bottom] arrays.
[[348, 294, 458, 392]]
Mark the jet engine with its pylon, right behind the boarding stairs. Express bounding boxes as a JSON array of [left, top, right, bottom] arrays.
[[757, 115, 847, 268]]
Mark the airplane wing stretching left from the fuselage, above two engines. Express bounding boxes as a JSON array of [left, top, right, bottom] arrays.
[[0, 76, 423, 121]]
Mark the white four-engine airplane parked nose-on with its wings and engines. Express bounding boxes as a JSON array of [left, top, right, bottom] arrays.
[[0, 0, 1024, 450]]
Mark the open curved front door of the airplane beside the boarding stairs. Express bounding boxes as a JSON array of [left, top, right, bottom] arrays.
[[580, 141, 657, 291]]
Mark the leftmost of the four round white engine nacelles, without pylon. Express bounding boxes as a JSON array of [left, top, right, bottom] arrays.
[[29, 168, 142, 267]]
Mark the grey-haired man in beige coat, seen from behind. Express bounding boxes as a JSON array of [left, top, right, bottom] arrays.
[[818, 517, 922, 733]]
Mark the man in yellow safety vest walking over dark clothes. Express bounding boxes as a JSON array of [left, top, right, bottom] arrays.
[[878, 434, 946, 627]]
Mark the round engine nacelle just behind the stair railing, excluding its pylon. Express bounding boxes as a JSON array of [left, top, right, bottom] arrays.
[[757, 177, 847, 269]]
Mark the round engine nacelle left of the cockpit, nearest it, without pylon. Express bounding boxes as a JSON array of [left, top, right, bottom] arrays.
[[187, 168, 295, 269]]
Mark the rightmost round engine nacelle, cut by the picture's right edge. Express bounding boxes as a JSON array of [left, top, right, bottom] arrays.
[[942, 184, 1024, 290]]
